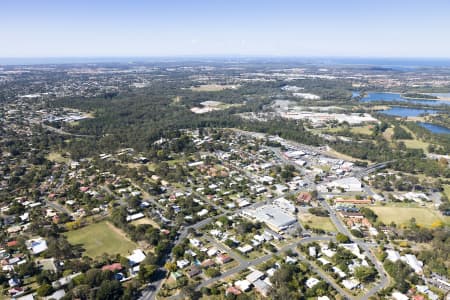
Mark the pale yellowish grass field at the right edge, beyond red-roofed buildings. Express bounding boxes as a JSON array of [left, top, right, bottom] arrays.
[[370, 206, 450, 227]]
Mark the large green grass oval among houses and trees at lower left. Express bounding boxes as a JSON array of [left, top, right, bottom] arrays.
[[66, 221, 137, 258]]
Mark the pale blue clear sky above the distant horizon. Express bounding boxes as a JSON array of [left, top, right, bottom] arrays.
[[0, 0, 450, 58]]
